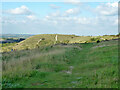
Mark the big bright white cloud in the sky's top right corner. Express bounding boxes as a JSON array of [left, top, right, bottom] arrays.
[[95, 3, 118, 16]]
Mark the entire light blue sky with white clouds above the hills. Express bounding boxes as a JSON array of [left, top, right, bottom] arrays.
[[0, 0, 118, 36]]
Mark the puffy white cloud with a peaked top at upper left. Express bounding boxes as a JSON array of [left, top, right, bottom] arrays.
[[6, 5, 32, 15]]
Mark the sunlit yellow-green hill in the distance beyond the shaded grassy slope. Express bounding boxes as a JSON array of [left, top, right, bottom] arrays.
[[2, 34, 118, 52]]
